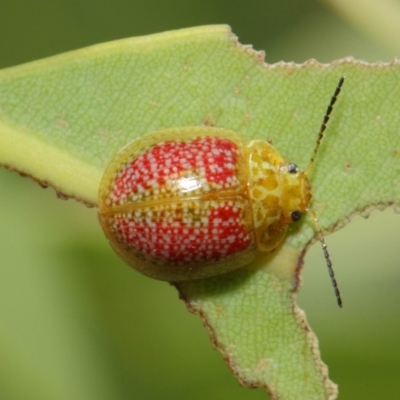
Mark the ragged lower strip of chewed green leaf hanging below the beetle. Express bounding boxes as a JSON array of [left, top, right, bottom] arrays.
[[178, 246, 337, 399]]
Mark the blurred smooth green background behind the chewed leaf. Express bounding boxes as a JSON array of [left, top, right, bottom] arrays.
[[0, 0, 400, 400]]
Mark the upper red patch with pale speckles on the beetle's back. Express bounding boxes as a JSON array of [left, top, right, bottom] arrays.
[[113, 137, 239, 198]]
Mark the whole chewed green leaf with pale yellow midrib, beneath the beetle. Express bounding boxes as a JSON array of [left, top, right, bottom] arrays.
[[0, 26, 400, 400]]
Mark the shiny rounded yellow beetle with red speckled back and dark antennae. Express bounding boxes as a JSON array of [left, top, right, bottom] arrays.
[[98, 78, 344, 306]]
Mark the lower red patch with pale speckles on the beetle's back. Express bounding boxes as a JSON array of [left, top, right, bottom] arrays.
[[114, 202, 252, 264]]
